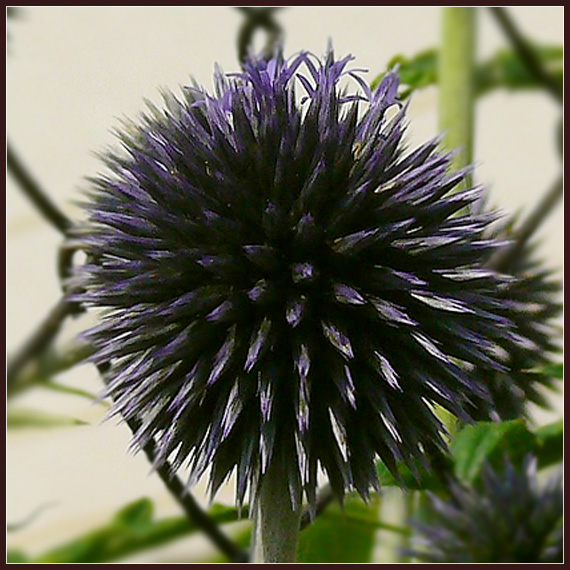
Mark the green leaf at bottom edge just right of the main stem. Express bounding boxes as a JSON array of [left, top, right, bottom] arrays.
[[297, 496, 379, 563]]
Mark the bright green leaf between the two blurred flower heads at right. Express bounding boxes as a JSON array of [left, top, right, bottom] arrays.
[[450, 420, 538, 483]]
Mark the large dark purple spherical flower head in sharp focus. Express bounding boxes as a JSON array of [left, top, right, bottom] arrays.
[[72, 46, 510, 504]]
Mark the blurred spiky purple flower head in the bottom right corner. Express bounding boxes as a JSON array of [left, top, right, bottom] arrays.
[[411, 456, 563, 563]]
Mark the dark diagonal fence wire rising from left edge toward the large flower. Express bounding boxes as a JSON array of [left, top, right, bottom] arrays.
[[6, 298, 77, 389]]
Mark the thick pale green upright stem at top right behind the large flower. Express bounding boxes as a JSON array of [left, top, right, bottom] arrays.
[[439, 6, 476, 186]]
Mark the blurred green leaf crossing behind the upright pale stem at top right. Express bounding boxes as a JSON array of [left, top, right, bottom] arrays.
[[371, 45, 564, 99]]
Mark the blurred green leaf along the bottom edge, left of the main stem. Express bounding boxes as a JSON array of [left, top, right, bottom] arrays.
[[20, 498, 238, 564]]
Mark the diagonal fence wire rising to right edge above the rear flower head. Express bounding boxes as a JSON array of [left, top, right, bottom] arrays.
[[488, 176, 564, 270]]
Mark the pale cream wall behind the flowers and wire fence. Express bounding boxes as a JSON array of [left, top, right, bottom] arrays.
[[6, 7, 564, 561]]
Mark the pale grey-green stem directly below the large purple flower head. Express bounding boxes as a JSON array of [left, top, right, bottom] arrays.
[[252, 463, 301, 564]]
